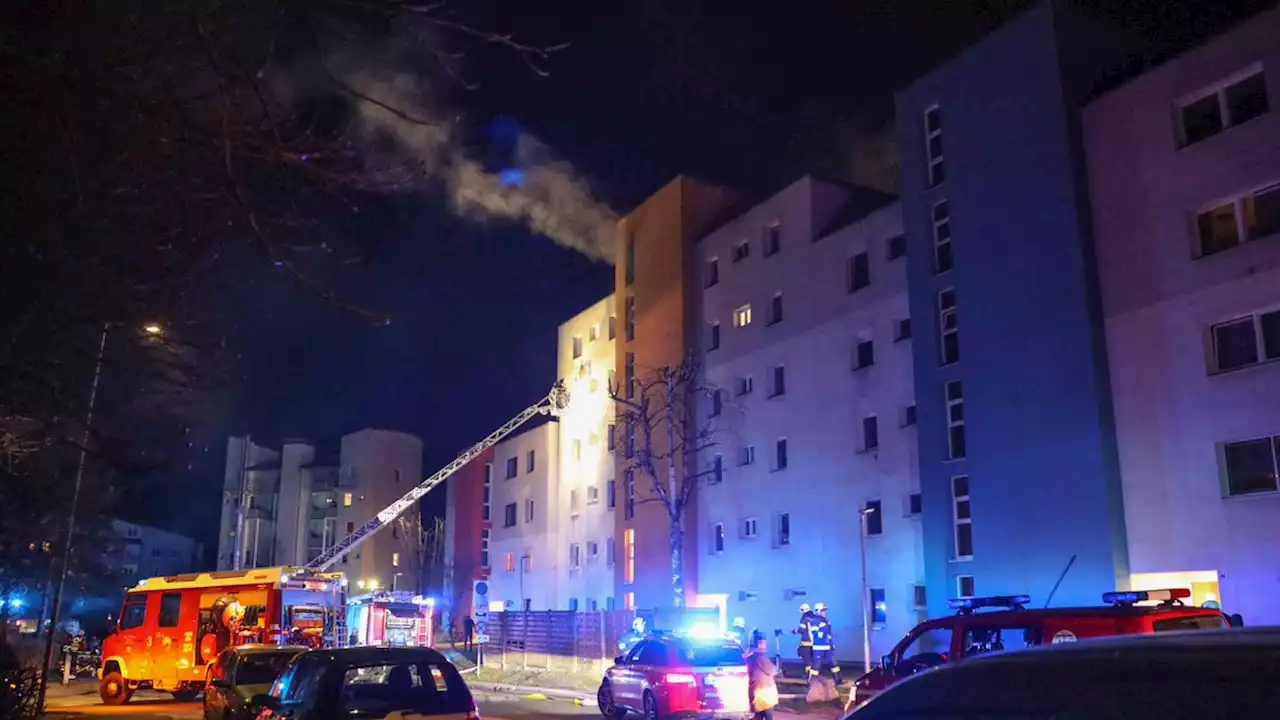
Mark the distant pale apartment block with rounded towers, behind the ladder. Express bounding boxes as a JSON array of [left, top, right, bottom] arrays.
[[218, 428, 422, 589]]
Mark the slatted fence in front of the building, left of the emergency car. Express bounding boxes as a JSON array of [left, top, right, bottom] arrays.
[[484, 610, 636, 673]]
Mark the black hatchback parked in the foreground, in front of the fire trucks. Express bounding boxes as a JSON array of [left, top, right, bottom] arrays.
[[252, 647, 480, 720]]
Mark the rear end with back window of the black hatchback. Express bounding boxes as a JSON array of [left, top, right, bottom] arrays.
[[342, 661, 471, 717]]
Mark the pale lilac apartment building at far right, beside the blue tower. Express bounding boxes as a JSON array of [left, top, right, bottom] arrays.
[[1080, 10, 1280, 624]]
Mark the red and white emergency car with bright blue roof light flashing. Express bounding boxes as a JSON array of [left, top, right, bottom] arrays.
[[596, 635, 751, 720]]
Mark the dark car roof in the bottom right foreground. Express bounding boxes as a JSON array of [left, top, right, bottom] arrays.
[[846, 628, 1280, 720]]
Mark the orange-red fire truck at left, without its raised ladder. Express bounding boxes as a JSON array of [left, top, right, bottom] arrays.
[[99, 568, 346, 705]]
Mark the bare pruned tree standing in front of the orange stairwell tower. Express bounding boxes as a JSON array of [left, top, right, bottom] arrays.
[[609, 354, 721, 607]]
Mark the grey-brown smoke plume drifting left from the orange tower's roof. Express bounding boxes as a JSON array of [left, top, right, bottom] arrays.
[[343, 67, 617, 263]]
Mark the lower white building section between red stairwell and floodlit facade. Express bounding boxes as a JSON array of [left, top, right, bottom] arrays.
[[488, 418, 567, 610]]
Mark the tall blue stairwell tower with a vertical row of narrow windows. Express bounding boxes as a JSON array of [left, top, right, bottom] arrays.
[[896, 0, 1141, 615]]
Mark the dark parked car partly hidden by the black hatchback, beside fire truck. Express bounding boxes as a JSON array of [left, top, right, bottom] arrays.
[[205, 644, 307, 720]]
